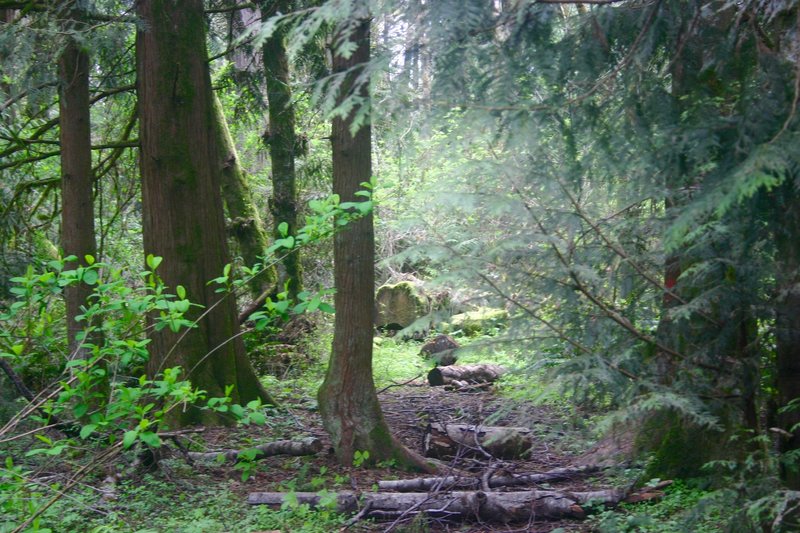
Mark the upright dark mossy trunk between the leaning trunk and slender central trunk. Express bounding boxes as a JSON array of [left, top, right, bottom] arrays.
[[260, 0, 303, 298]]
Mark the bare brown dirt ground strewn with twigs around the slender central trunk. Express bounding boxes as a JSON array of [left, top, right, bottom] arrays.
[[181, 383, 611, 533]]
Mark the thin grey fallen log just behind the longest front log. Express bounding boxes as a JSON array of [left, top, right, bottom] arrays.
[[378, 466, 599, 492]]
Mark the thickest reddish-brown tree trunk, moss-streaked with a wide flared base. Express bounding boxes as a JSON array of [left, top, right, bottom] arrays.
[[136, 0, 269, 425]]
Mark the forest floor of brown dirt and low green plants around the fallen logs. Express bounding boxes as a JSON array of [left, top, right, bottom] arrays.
[[0, 332, 716, 533]]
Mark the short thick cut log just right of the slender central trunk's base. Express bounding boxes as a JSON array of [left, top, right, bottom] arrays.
[[423, 424, 533, 459]]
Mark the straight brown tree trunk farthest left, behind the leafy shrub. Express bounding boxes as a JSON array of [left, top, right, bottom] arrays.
[[58, 7, 97, 359]]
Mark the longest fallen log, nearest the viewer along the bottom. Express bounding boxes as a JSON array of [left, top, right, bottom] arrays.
[[247, 489, 625, 523]]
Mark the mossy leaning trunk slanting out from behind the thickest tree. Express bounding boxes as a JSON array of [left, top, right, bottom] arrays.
[[214, 96, 276, 297]]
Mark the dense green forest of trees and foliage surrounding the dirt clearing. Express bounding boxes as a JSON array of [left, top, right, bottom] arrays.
[[0, 0, 800, 531]]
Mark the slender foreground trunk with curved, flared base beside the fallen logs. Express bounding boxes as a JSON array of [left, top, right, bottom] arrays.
[[318, 16, 432, 468]]
